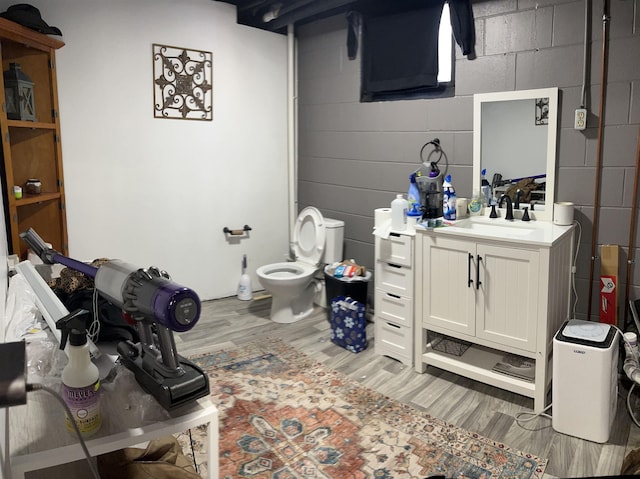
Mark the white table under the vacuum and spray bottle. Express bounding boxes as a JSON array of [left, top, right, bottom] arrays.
[[5, 362, 218, 479]]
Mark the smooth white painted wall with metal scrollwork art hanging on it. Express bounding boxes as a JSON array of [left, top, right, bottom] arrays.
[[0, 0, 288, 299]]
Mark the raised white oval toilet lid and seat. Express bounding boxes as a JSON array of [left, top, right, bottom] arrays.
[[293, 206, 326, 265]]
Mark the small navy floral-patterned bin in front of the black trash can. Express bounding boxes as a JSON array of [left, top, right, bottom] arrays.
[[329, 296, 367, 353]]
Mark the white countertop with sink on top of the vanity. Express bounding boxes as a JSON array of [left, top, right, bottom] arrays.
[[416, 215, 574, 246]]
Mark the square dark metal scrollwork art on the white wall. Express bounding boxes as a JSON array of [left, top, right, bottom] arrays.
[[153, 43, 213, 120]]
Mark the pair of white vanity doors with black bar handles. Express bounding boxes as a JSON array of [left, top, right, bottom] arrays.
[[421, 235, 540, 352]]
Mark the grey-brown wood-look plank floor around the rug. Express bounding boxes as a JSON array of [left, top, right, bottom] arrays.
[[175, 293, 640, 477]]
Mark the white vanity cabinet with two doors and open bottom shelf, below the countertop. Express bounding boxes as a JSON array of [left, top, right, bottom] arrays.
[[415, 226, 573, 412]]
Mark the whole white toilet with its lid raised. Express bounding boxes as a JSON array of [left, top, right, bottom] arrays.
[[256, 206, 344, 323]]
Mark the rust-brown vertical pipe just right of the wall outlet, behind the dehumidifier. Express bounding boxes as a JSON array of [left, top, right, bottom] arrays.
[[587, 0, 609, 320]]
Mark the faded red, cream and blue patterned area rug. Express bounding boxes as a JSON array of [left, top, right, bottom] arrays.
[[178, 339, 547, 479]]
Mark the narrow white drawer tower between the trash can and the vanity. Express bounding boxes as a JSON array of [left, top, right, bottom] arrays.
[[374, 230, 415, 366]]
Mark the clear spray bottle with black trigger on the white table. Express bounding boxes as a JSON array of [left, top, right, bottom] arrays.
[[56, 309, 102, 437]]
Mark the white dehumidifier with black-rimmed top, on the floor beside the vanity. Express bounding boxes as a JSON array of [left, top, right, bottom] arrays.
[[551, 319, 618, 443]]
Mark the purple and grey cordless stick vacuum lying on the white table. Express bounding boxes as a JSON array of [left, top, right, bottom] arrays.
[[20, 228, 209, 410]]
